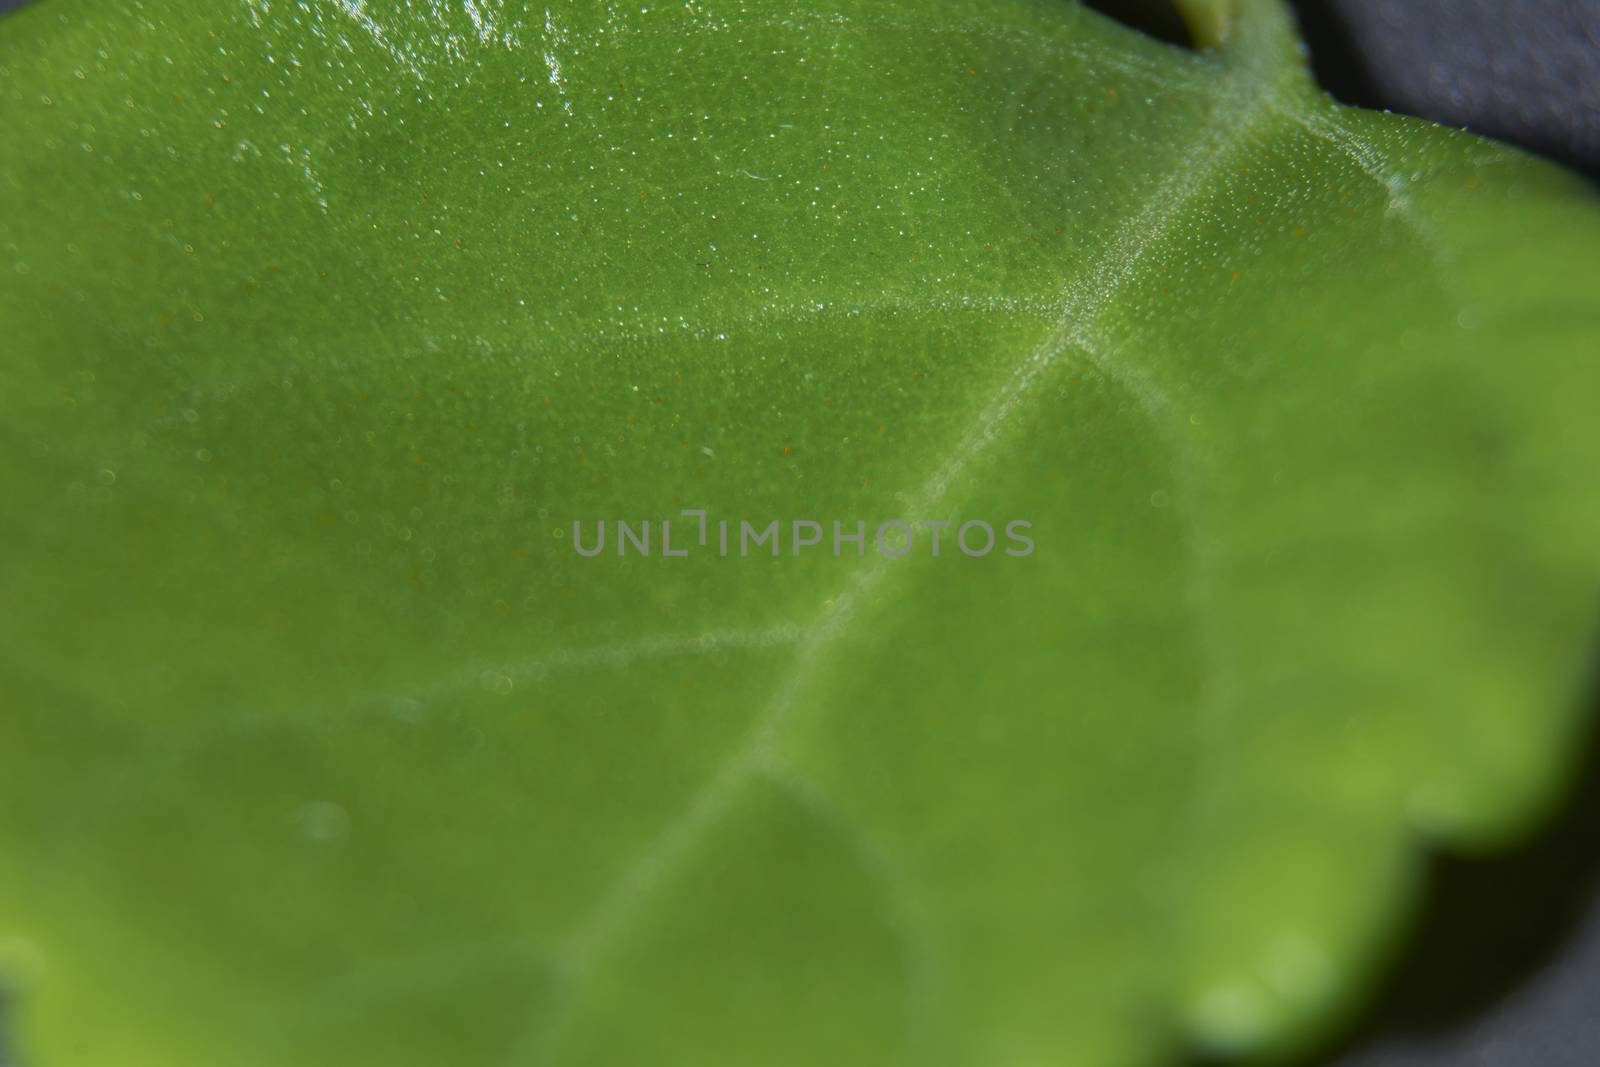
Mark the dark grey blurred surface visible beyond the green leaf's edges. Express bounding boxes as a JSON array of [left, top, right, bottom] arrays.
[[0, 0, 1600, 1067]]
